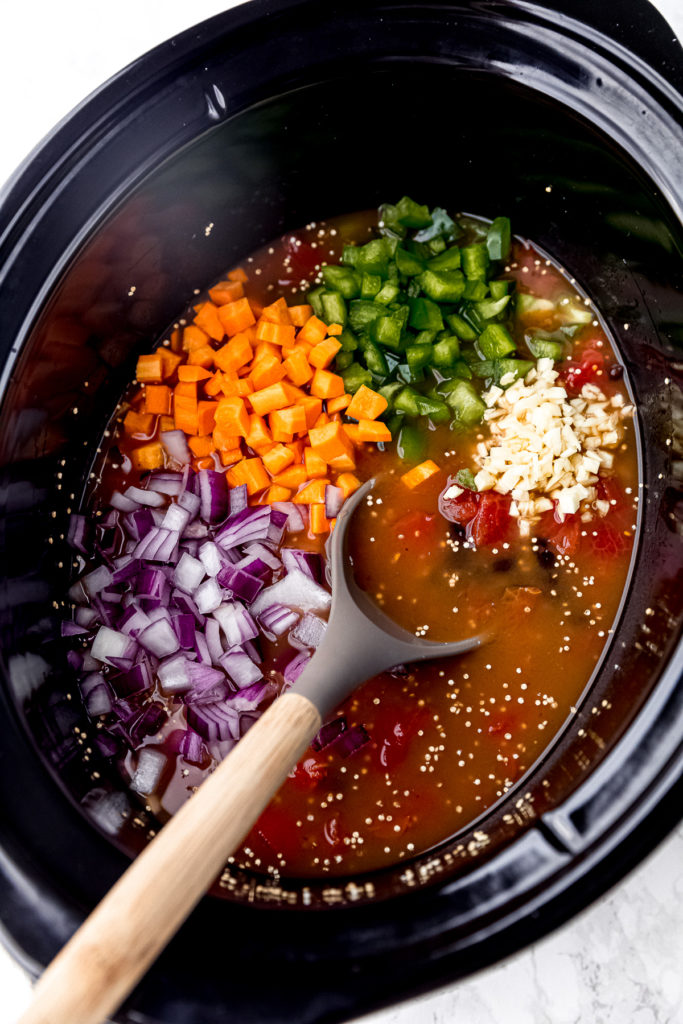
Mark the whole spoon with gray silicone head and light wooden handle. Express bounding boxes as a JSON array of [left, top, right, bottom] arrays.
[[19, 480, 482, 1024]]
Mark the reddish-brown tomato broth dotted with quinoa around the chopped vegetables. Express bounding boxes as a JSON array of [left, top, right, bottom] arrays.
[[66, 201, 638, 877]]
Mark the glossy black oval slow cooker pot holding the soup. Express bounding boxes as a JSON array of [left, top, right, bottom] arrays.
[[0, 0, 683, 1024]]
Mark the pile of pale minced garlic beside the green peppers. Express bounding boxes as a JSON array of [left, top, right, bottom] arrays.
[[474, 359, 633, 536]]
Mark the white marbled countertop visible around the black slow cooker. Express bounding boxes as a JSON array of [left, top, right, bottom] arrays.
[[0, 0, 683, 1024]]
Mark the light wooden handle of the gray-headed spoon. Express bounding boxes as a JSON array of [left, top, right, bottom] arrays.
[[18, 693, 321, 1024]]
